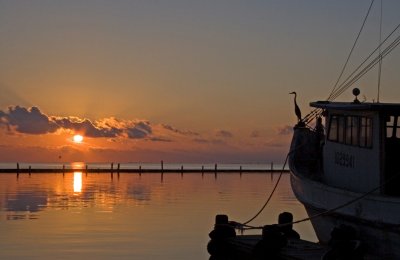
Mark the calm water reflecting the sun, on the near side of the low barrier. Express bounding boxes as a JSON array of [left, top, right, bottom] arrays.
[[0, 172, 316, 260]]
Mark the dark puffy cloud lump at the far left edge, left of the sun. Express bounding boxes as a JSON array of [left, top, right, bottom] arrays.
[[0, 106, 58, 134]]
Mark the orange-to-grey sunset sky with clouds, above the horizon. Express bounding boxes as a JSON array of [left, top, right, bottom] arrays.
[[0, 0, 400, 162]]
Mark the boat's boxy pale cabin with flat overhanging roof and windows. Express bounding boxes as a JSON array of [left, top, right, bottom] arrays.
[[310, 101, 400, 196]]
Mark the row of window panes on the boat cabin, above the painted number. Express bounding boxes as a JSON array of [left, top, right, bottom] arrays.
[[328, 115, 372, 147]]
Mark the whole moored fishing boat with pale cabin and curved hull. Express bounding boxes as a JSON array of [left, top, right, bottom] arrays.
[[289, 96, 400, 259]]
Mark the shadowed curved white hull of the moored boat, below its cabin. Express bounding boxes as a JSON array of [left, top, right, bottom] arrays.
[[291, 169, 400, 259]]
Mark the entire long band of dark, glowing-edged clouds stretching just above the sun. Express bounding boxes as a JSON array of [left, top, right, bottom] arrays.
[[0, 106, 203, 142]]
